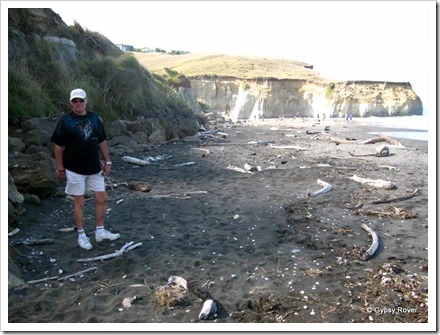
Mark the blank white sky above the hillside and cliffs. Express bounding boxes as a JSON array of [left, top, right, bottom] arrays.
[[43, 1, 436, 113]]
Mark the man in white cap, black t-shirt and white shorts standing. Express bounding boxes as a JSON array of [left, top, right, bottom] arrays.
[[51, 88, 120, 250]]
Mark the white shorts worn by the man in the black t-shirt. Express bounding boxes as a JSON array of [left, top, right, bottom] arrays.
[[65, 170, 105, 195]]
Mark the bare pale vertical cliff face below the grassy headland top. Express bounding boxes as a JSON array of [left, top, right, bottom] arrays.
[[180, 78, 423, 121]]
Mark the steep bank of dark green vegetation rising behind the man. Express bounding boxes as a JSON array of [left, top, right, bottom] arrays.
[[8, 8, 195, 131]]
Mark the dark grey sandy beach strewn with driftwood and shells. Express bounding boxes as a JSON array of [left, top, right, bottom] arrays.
[[8, 119, 435, 330]]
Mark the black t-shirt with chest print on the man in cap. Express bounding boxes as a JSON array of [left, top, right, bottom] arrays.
[[51, 112, 107, 175]]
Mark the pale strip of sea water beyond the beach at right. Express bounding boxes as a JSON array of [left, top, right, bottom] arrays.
[[353, 113, 430, 141]]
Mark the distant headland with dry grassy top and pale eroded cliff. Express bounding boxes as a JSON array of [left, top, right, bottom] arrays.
[[135, 53, 423, 120]]
